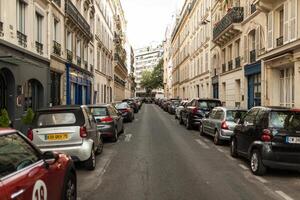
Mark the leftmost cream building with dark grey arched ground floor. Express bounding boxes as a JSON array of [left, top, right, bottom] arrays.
[[0, 0, 52, 128]]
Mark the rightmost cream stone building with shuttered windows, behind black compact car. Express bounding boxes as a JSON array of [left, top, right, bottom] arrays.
[[256, 0, 300, 107]]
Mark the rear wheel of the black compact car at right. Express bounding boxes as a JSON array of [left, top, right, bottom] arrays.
[[250, 150, 267, 176]]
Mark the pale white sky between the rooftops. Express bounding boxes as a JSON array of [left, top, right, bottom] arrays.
[[121, 0, 183, 49]]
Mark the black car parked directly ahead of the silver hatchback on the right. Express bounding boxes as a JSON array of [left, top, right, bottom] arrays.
[[179, 98, 221, 129]]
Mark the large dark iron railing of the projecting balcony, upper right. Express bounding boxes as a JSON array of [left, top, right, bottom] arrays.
[[213, 7, 244, 40]]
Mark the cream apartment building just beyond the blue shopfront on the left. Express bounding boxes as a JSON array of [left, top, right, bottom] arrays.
[[93, 0, 114, 104]]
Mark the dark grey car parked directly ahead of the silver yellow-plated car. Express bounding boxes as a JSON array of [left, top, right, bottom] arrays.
[[88, 104, 124, 142]]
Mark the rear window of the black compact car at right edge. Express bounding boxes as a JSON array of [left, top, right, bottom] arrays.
[[269, 111, 300, 131]]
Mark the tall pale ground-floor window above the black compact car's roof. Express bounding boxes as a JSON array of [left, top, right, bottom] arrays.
[[280, 68, 295, 107]]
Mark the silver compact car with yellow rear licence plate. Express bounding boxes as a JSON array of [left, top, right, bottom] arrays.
[[27, 106, 103, 170]]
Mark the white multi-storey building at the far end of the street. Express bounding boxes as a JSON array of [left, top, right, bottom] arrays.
[[134, 44, 163, 97]]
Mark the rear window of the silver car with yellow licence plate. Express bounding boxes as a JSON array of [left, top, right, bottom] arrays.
[[37, 112, 76, 127]]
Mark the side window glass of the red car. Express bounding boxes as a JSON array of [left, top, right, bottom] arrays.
[[0, 133, 40, 178]]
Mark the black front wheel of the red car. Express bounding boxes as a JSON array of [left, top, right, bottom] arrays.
[[62, 172, 77, 200]]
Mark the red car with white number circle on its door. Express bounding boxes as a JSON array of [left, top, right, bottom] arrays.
[[0, 128, 77, 200]]
